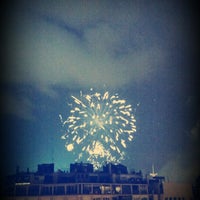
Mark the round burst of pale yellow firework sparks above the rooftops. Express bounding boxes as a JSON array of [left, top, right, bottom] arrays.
[[60, 92, 136, 168]]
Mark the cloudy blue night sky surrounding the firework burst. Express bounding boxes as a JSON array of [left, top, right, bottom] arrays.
[[0, 0, 200, 184]]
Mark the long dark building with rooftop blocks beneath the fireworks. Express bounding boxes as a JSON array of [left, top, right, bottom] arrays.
[[2, 163, 193, 200]]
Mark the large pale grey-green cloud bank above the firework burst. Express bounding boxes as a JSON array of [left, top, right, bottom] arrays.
[[2, 1, 191, 94]]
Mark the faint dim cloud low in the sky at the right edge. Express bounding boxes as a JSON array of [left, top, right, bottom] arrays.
[[159, 120, 200, 182]]
